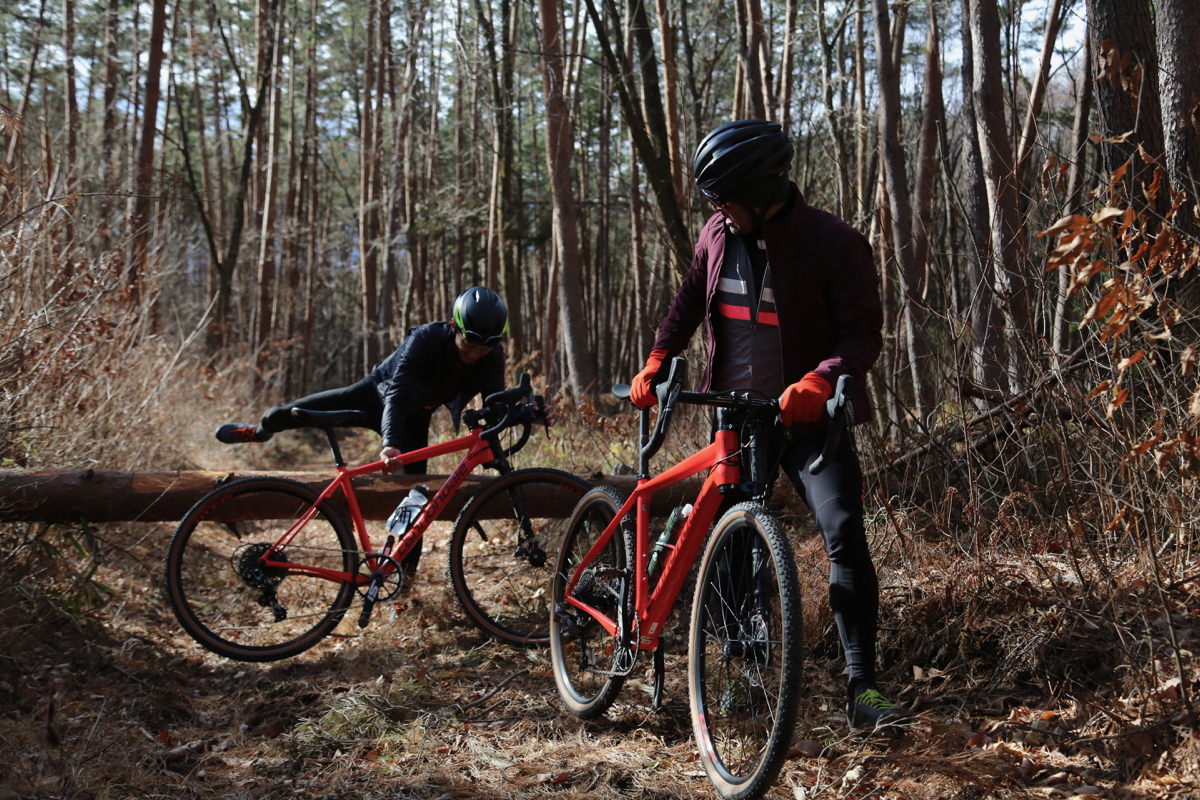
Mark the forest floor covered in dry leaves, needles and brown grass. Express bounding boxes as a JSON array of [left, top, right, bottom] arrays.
[[0, 431, 1200, 800]]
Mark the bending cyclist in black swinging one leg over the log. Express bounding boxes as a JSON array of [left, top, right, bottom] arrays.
[[216, 287, 509, 475]]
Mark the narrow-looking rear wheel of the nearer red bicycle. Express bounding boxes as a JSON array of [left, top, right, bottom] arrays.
[[550, 486, 632, 720]]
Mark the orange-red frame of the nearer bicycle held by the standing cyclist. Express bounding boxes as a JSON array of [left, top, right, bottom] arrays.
[[565, 431, 742, 650]]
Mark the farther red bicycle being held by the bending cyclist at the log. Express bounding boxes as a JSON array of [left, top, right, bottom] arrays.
[[164, 375, 588, 661]]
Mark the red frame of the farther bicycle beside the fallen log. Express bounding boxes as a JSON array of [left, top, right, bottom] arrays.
[[260, 428, 497, 585]]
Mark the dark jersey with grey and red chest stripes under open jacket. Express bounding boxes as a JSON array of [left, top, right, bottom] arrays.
[[710, 234, 784, 397]]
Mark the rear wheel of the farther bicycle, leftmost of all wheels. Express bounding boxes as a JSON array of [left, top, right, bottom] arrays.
[[164, 477, 359, 661]]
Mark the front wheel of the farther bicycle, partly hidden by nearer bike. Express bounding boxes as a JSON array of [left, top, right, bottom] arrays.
[[448, 469, 588, 644]]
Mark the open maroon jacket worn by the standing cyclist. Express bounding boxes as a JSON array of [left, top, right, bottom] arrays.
[[654, 187, 883, 433]]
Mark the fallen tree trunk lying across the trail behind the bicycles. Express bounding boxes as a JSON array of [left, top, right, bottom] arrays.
[[0, 469, 694, 523]]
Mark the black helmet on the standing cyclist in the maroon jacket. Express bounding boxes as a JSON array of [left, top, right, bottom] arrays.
[[692, 120, 794, 206]]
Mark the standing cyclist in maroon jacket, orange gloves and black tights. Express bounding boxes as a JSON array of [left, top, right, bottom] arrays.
[[630, 120, 902, 727]]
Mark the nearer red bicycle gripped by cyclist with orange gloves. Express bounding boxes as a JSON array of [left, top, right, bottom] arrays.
[[550, 359, 850, 800]]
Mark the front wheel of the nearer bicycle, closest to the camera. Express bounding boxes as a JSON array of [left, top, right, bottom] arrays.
[[688, 503, 803, 800]]
